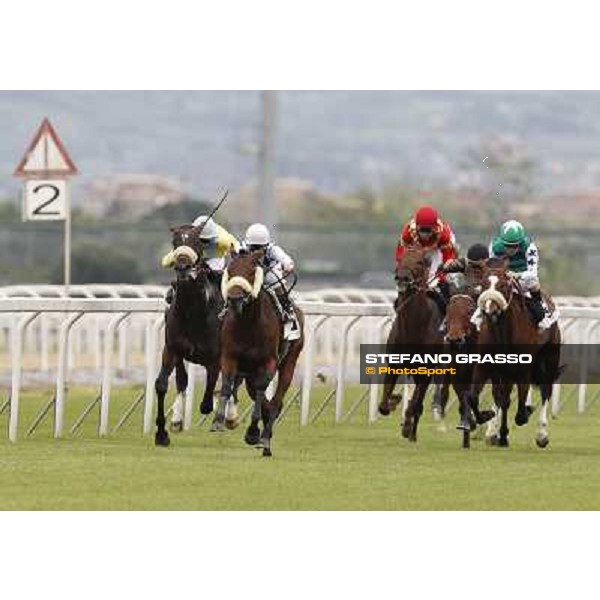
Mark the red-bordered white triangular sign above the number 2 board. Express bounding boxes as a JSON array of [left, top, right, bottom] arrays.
[[15, 119, 77, 177]]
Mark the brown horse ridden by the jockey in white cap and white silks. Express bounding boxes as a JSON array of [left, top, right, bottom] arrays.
[[213, 251, 304, 456]]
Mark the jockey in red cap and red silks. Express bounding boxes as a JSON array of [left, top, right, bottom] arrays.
[[396, 206, 457, 303]]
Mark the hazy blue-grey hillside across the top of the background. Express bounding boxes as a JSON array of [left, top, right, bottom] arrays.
[[0, 91, 600, 199]]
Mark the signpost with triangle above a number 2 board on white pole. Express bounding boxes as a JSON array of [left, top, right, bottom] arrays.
[[14, 118, 77, 296]]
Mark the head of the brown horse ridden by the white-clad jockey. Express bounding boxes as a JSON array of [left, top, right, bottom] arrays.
[[221, 250, 264, 315]]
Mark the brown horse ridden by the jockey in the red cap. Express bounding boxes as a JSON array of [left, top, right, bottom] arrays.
[[379, 248, 444, 442]]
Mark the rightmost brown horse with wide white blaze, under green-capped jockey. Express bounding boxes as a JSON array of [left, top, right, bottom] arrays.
[[470, 260, 562, 448]]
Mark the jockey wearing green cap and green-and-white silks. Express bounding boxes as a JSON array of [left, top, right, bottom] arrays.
[[490, 220, 546, 324]]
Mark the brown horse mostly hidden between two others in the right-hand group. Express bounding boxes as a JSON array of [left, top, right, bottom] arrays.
[[444, 294, 495, 448]]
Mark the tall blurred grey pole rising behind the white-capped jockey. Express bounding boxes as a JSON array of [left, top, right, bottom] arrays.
[[257, 91, 277, 230]]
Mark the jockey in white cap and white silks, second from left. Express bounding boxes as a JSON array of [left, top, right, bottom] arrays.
[[242, 223, 296, 327]]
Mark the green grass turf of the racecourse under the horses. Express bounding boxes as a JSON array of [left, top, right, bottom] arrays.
[[0, 388, 600, 510]]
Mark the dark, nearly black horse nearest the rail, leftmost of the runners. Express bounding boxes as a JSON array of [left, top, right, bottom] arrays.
[[155, 225, 225, 446]]
